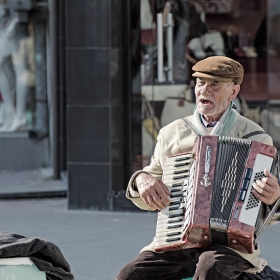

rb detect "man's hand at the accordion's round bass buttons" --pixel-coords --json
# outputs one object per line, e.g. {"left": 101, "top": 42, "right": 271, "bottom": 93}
{"left": 253, "top": 169, "right": 280, "bottom": 205}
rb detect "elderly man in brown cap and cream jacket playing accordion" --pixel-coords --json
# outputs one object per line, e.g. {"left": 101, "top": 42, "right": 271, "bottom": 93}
{"left": 116, "top": 56, "right": 280, "bottom": 280}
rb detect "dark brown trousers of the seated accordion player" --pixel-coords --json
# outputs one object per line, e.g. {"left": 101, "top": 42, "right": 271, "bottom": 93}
{"left": 116, "top": 245, "right": 280, "bottom": 280}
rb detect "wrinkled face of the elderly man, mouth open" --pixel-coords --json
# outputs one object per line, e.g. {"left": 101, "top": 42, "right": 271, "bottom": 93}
{"left": 195, "top": 78, "right": 240, "bottom": 121}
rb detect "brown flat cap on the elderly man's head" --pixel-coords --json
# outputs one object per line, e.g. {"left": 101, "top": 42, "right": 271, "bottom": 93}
{"left": 192, "top": 56, "right": 244, "bottom": 84}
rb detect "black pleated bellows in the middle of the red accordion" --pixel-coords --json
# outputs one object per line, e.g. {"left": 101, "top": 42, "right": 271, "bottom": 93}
{"left": 210, "top": 138, "right": 251, "bottom": 245}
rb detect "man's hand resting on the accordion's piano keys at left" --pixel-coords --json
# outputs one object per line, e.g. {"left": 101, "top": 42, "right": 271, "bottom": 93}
{"left": 135, "top": 173, "right": 171, "bottom": 210}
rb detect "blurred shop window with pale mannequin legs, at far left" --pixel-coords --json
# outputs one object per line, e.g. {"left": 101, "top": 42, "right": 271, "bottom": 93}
{"left": 0, "top": 0, "right": 50, "bottom": 171}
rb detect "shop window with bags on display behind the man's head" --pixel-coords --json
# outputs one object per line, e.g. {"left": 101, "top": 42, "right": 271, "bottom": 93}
{"left": 131, "top": 0, "right": 280, "bottom": 172}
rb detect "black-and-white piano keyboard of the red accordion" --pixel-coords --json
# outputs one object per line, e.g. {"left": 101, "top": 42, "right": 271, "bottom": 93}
{"left": 156, "top": 154, "right": 193, "bottom": 247}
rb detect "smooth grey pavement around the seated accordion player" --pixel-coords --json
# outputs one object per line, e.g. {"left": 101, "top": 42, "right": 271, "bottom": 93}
{"left": 0, "top": 198, "right": 280, "bottom": 280}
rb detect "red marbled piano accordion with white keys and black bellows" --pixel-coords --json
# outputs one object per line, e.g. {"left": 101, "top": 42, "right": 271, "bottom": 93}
{"left": 155, "top": 135, "right": 277, "bottom": 254}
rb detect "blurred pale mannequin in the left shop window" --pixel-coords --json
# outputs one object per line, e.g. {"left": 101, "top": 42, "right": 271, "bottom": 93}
{"left": 0, "top": 11, "right": 35, "bottom": 132}
